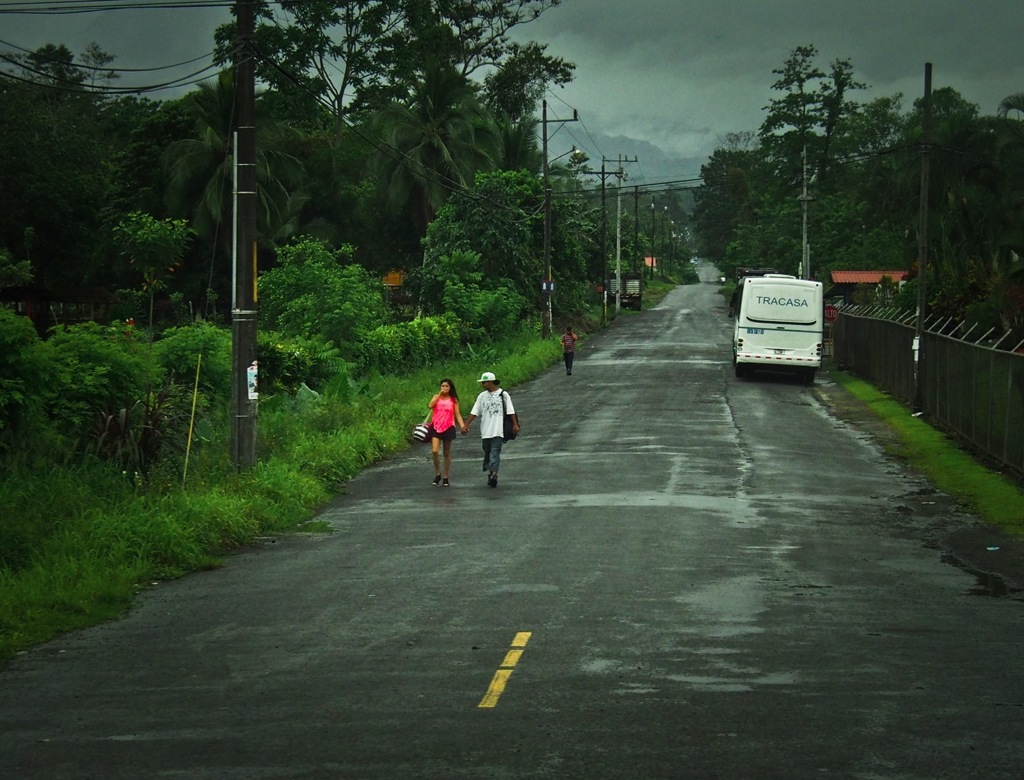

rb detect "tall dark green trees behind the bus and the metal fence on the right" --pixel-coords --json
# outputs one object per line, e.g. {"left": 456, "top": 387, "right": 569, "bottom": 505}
{"left": 694, "top": 46, "right": 1024, "bottom": 329}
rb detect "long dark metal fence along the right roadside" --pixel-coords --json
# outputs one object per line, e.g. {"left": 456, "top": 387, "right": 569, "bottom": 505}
{"left": 833, "top": 306, "right": 1024, "bottom": 477}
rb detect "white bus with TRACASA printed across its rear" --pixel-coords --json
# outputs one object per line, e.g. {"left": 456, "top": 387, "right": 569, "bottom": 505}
{"left": 732, "top": 273, "right": 824, "bottom": 384}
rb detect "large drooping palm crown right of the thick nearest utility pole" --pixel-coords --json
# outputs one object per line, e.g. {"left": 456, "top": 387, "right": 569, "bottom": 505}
{"left": 373, "top": 61, "right": 499, "bottom": 235}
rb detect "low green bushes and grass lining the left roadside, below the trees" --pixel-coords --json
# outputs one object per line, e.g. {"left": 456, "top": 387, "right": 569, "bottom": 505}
{"left": 0, "top": 269, "right": 688, "bottom": 662}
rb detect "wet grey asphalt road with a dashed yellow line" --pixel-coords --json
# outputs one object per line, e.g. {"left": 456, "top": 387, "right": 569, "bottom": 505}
{"left": 0, "top": 269, "right": 1024, "bottom": 780}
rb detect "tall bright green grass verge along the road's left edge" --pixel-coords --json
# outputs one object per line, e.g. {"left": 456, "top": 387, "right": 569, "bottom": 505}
{"left": 0, "top": 334, "right": 561, "bottom": 662}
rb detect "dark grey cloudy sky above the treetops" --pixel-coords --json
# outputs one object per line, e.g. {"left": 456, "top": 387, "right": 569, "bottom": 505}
{"left": 0, "top": 0, "right": 1024, "bottom": 179}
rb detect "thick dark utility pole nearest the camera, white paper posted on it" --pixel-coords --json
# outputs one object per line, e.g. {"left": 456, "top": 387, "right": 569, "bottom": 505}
{"left": 231, "top": 0, "right": 258, "bottom": 469}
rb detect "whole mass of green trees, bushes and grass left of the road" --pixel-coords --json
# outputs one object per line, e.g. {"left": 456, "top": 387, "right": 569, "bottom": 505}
{"left": 0, "top": 0, "right": 684, "bottom": 667}
